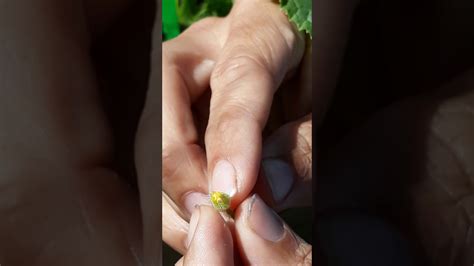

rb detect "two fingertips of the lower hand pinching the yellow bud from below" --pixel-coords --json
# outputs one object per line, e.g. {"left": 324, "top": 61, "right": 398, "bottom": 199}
{"left": 177, "top": 194, "right": 312, "bottom": 265}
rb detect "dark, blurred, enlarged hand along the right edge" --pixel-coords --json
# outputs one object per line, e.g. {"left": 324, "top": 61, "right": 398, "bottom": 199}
{"left": 317, "top": 70, "right": 474, "bottom": 266}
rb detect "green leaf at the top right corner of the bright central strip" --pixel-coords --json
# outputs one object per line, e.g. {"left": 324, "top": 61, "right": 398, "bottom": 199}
{"left": 280, "top": 0, "right": 313, "bottom": 39}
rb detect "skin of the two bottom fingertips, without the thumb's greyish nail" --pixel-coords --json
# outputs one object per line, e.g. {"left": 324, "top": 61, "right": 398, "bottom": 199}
{"left": 176, "top": 203, "right": 312, "bottom": 265}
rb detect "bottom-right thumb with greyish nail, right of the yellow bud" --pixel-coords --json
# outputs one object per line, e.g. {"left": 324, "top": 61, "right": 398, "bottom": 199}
{"left": 235, "top": 194, "right": 312, "bottom": 265}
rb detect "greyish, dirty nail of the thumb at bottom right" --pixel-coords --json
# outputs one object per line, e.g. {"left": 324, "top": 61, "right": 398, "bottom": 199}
{"left": 247, "top": 194, "right": 285, "bottom": 242}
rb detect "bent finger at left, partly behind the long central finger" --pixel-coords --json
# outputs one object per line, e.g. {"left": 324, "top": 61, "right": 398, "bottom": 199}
{"left": 158, "top": 19, "right": 223, "bottom": 214}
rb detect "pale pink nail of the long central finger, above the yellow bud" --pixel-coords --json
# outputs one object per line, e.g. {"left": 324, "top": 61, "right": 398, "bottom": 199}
{"left": 211, "top": 160, "right": 237, "bottom": 197}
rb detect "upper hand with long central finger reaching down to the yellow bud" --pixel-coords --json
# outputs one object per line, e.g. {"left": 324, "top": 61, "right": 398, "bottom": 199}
{"left": 136, "top": 1, "right": 304, "bottom": 258}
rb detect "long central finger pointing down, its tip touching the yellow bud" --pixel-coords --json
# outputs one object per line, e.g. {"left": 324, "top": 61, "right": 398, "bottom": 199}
{"left": 205, "top": 1, "right": 304, "bottom": 207}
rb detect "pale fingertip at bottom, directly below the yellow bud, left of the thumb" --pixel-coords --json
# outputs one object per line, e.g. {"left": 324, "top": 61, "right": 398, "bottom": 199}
{"left": 177, "top": 206, "right": 234, "bottom": 265}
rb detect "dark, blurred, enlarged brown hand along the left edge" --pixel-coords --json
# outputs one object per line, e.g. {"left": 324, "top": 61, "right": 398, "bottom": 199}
{"left": 0, "top": 0, "right": 142, "bottom": 265}
